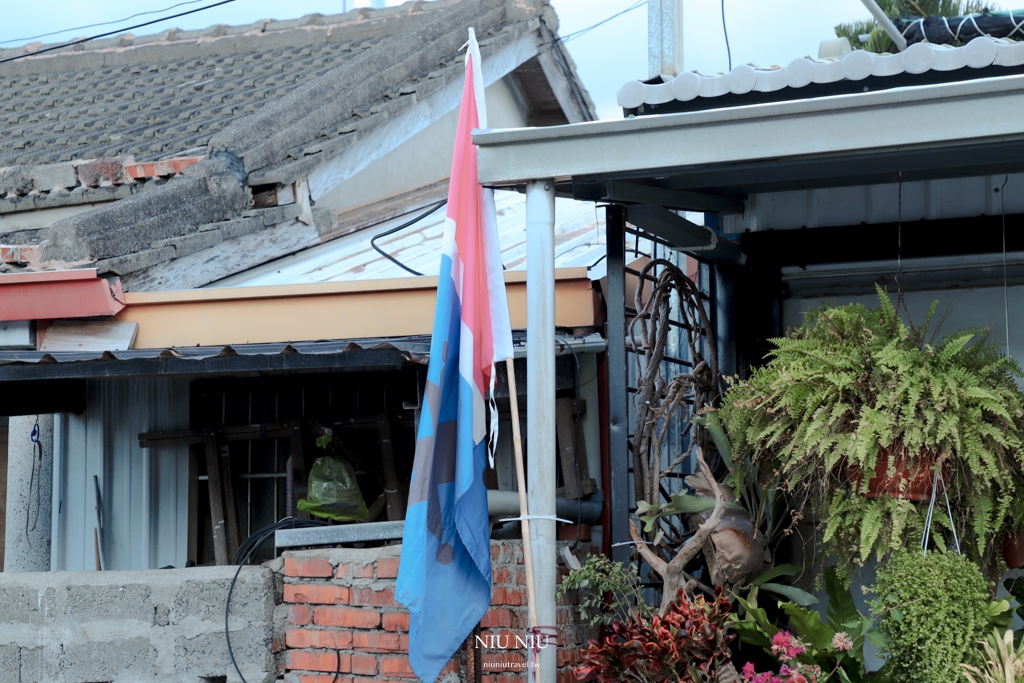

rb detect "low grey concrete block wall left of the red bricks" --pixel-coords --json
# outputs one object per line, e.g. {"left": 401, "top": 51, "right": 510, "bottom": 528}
{"left": 0, "top": 566, "right": 276, "bottom": 683}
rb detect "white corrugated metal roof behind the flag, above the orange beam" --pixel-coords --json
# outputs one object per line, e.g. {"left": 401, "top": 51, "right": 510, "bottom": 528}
{"left": 210, "top": 191, "right": 605, "bottom": 287}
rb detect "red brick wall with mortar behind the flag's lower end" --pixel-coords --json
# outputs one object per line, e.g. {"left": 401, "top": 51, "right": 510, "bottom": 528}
{"left": 280, "top": 541, "right": 593, "bottom": 683}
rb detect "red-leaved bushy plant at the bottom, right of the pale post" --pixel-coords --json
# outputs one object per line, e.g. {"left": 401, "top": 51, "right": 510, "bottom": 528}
{"left": 575, "top": 588, "right": 735, "bottom": 683}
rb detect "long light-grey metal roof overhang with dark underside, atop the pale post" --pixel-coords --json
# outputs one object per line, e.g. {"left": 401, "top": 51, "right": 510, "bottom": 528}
{"left": 473, "top": 76, "right": 1024, "bottom": 195}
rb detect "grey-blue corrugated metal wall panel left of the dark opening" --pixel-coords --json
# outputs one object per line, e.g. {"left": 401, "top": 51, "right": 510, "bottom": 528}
{"left": 53, "top": 379, "right": 188, "bottom": 571}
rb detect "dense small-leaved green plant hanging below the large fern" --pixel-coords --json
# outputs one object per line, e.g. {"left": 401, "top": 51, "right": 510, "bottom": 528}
{"left": 872, "top": 550, "right": 989, "bottom": 683}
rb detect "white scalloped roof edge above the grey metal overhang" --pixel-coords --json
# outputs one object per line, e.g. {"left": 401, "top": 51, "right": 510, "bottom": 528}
{"left": 617, "top": 38, "right": 1024, "bottom": 111}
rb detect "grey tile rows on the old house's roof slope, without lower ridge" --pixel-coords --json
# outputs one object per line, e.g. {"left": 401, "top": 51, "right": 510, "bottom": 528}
{"left": 0, "top": 0, "right": 536, "bottom": 167}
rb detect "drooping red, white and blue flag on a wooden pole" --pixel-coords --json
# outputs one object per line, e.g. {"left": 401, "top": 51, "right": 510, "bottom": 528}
{"left": 395, "top": 29, "right": 512, "bottom": 683}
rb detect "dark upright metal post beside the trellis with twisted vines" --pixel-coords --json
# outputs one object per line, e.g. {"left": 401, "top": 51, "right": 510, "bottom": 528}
{"left": 604, "top": 205, "right": 631, "bottom": 562}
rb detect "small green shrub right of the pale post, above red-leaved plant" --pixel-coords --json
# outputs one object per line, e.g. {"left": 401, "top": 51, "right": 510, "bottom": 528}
{"left": 555, "top": 555, "right": 654, "bottom": 626}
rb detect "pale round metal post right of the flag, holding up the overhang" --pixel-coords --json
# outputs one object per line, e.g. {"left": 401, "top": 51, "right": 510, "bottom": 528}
{"left": 526, "top": 180, "right": 558, "bottom": 683}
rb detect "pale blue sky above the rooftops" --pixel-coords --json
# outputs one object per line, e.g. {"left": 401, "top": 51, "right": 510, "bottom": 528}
{"left": 6, "top": 0, "right": 1024, "bottom": 119}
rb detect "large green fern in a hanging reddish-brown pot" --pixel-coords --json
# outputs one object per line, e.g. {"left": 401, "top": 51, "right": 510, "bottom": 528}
{"left": 721, "top": 288, "right": 1024, "bottom": 581}
